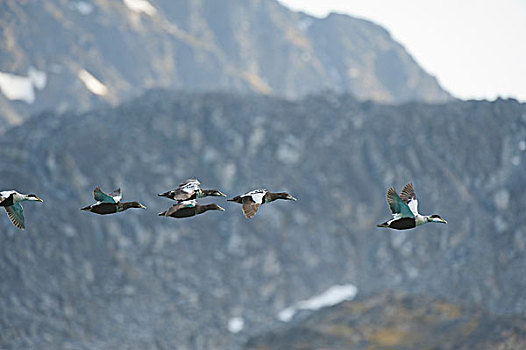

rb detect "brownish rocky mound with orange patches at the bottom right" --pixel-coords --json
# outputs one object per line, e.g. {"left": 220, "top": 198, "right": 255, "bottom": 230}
{"left": 246, "top": 293, "right": 526, "bottom": 350}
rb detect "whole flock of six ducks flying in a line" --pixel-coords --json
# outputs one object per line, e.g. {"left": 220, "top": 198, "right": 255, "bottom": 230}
{"left": 0, "top": 178, "right": 447, "bottom": 230}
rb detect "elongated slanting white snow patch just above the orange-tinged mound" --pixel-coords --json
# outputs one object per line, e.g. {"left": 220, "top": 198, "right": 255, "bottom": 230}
{"left": 278, "top": 284, "right": 358, "bottom": 322}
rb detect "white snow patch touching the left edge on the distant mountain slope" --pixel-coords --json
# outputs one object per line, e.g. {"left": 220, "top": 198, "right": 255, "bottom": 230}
{"left": 0, "top": 67, "right": 47, "bottom": 104}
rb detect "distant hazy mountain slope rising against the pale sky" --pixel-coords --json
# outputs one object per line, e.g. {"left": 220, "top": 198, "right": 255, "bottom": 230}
{"left": 0, "top": 0, "right": 450, "bottom": 132}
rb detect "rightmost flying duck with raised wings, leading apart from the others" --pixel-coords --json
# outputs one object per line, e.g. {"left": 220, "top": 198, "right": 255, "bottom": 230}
{"left": 376, "top": 183, "right": 447, "bottom": 230}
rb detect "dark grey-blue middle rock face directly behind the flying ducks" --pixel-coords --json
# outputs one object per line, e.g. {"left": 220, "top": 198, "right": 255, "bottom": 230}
{"left": 0, "top": 91, "right": 526, "bottom": 349}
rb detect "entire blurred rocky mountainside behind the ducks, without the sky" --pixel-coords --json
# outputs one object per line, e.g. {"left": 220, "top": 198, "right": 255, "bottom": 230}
{"left": 0, "top": 0, "right": 526, "bottom": 350}
